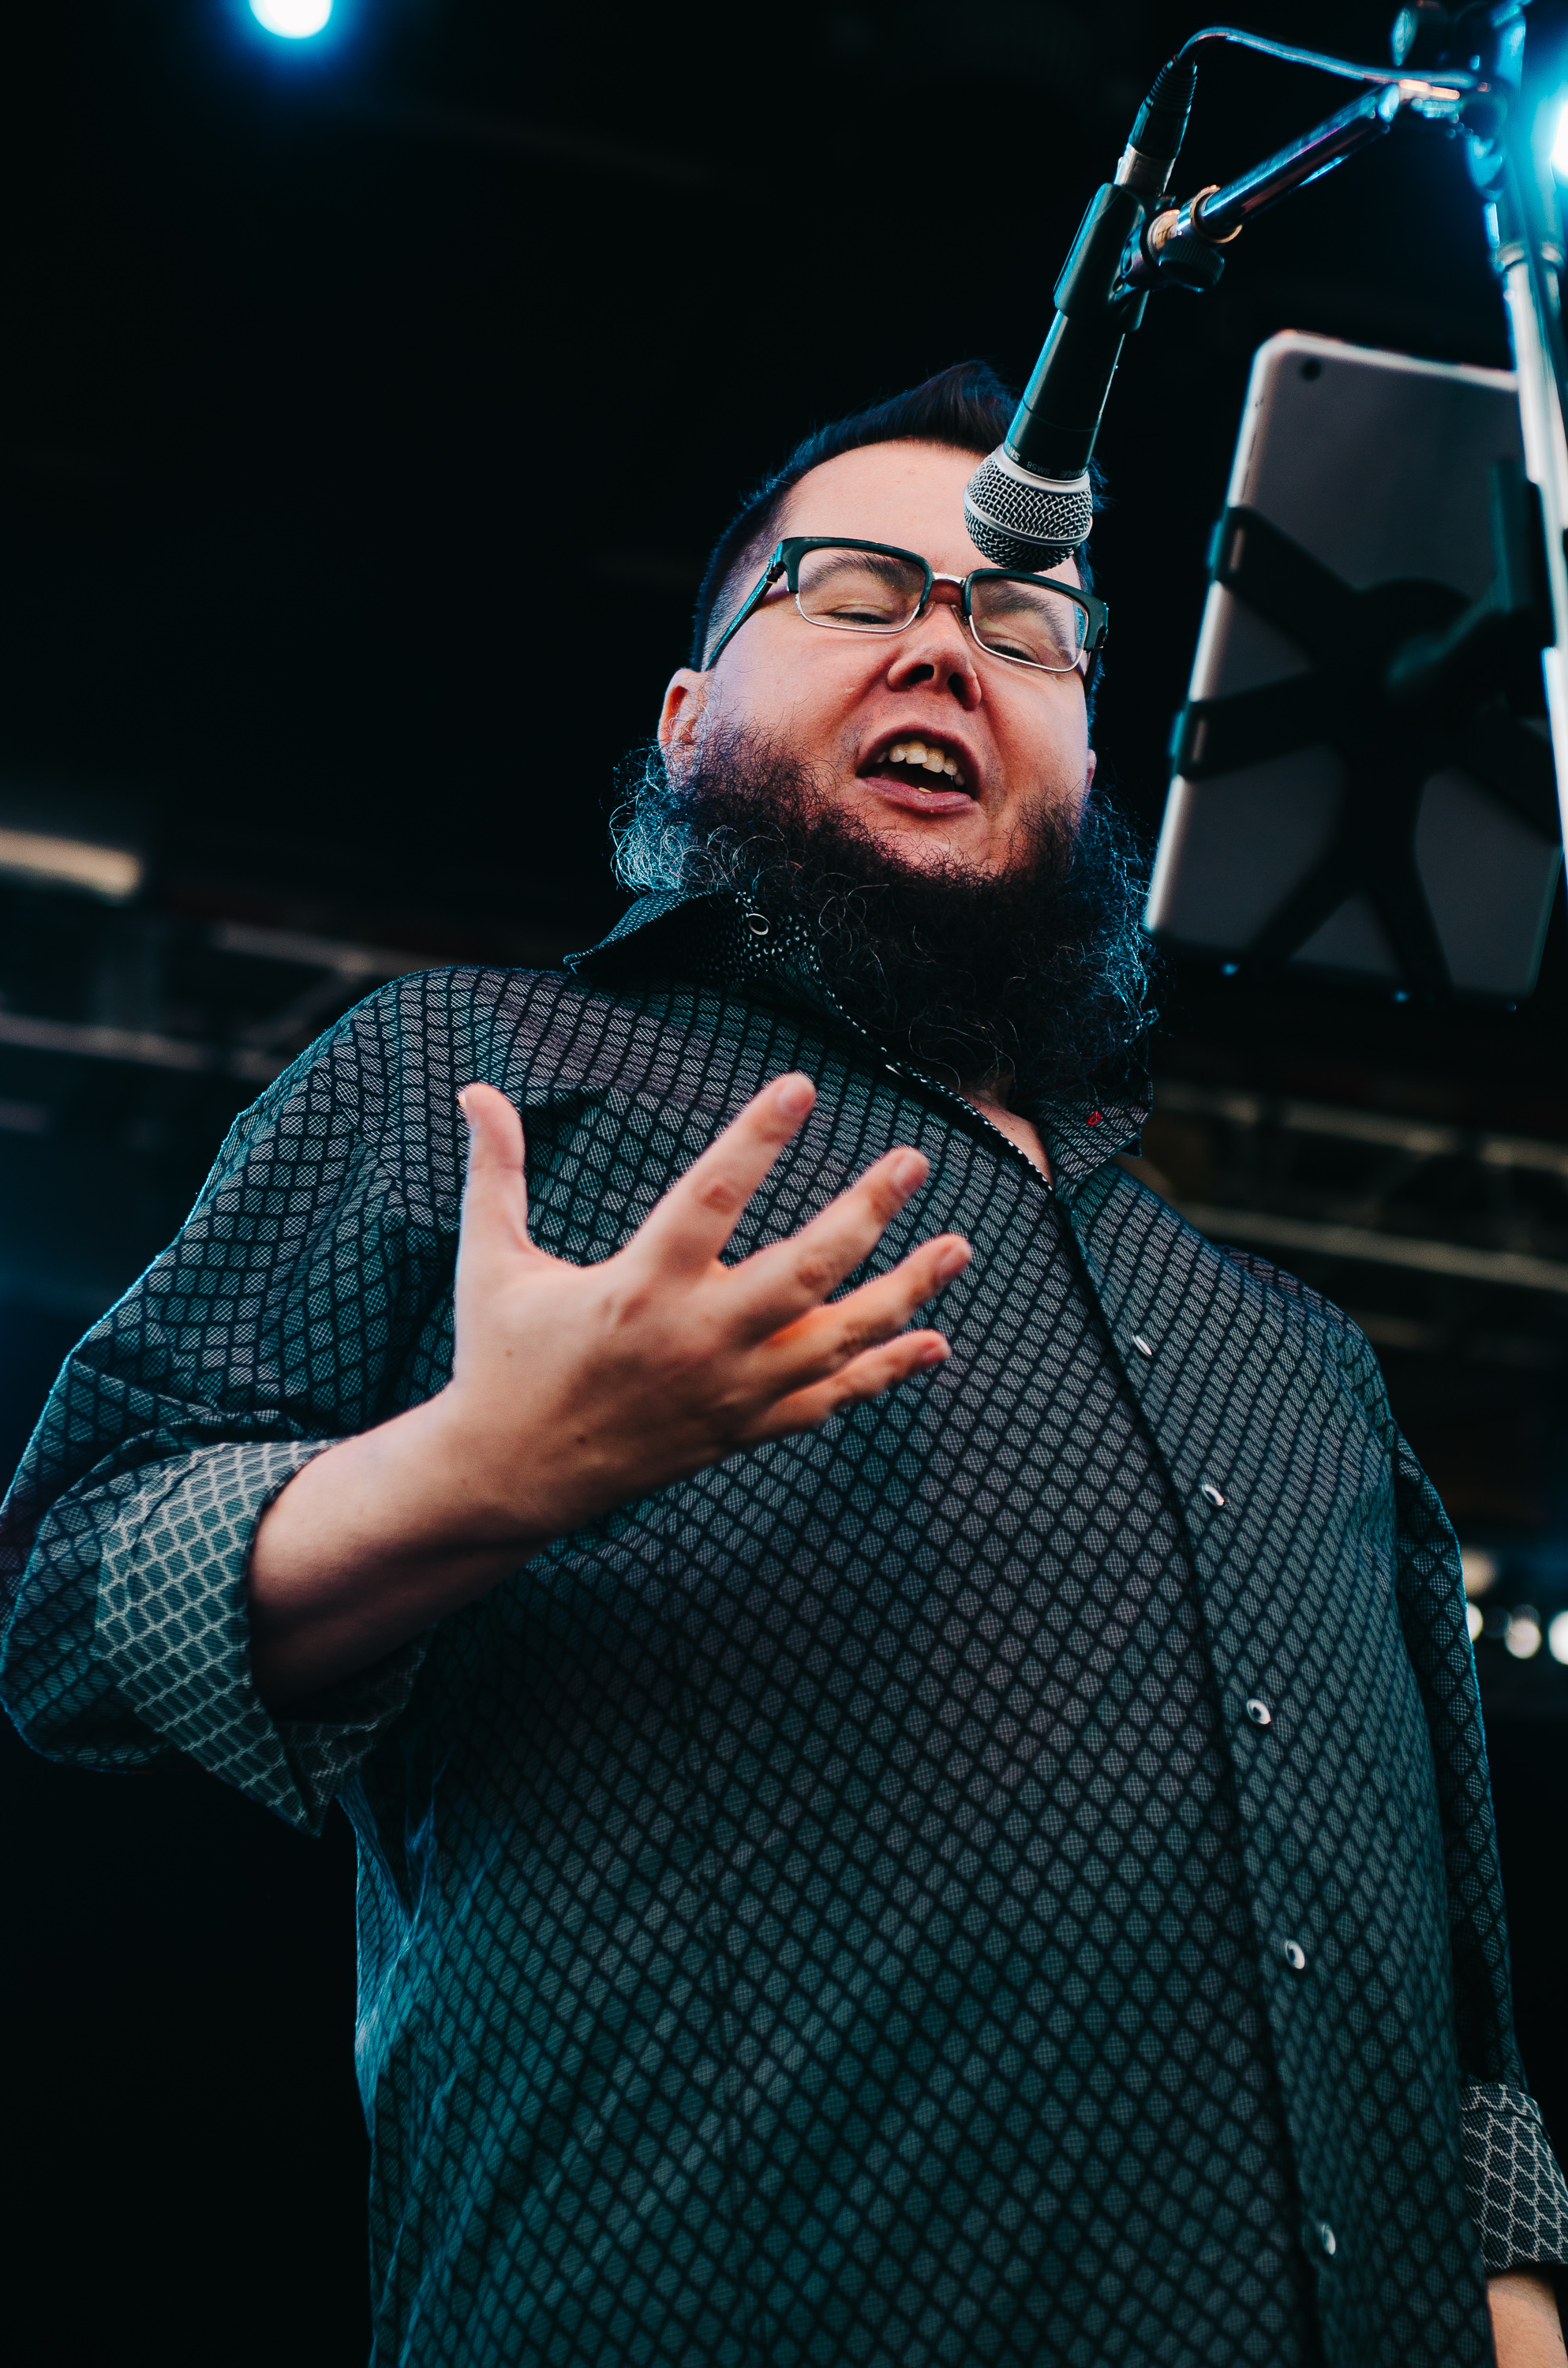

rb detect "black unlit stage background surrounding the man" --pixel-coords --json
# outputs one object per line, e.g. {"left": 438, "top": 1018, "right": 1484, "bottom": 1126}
{"left": 0, "top": 0, "right": 1568, "bottom": 2368}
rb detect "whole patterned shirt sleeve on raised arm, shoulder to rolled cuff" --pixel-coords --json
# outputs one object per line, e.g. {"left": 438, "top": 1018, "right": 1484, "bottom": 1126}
{"left": 0, "top": 999, "right": 455, "bottom": 1830}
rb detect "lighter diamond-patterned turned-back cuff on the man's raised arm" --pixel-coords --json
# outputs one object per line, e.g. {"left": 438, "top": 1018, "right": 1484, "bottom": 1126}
{"left": 95, "top": 1440, "right": 424, "bottom": 1833}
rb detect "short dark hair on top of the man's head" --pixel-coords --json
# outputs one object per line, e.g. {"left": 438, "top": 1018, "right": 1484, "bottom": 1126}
{"left": 691, "top": 362, "right": 1099, "bottom": 670}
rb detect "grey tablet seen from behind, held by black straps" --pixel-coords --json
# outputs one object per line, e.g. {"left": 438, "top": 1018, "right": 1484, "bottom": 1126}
{"left": 1147, "top": 332, "right": 1561, "bottom": 1002}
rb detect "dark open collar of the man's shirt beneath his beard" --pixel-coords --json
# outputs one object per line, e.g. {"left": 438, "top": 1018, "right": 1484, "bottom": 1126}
{"left": 566, "top": 888, "right": 1151, "bottom": 1191}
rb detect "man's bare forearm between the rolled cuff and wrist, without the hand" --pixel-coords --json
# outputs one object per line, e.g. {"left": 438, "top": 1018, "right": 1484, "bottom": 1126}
{"left": 249, "top": 1390, "right": 552, "bottom": 1703}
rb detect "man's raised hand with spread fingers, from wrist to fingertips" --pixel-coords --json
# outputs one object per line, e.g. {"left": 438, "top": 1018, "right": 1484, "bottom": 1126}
{"left": 447, "top": 1077, "right": 969, "bottom": 1542}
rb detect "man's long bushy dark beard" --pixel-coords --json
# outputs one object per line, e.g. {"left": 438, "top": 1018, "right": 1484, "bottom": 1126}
{"left": 618, "top": 729, "right": 1156, "bottom": 1103}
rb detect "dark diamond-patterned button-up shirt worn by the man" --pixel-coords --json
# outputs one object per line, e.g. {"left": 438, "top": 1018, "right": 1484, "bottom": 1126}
{"left": 0, "top": 897, "right": 1568, "bottom": 2368}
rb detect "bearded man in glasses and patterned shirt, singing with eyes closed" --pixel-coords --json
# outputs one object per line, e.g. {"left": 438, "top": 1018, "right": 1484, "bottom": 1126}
{"left": 2, "top": 369, "right": 1568, "bottom": 2368}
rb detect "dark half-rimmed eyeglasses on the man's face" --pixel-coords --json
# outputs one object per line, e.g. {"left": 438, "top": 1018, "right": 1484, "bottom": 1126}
{"left": 708, "top": 535, "right": 1109, "bottom": 680}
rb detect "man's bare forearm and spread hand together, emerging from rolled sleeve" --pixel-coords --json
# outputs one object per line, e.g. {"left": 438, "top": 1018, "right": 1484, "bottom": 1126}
{"left": 249, "top": 1075, "right": 969, "bottom": 1700}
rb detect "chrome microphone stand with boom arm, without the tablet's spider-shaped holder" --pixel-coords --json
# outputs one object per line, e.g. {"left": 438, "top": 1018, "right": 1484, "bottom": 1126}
{"left": 1144, "top": 0, "right": 1568, "bottom": 843}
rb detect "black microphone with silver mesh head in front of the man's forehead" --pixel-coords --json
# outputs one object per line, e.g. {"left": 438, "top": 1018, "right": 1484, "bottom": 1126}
{"left": 964, "top": 57, "right": 1203, "bottom": 573}
